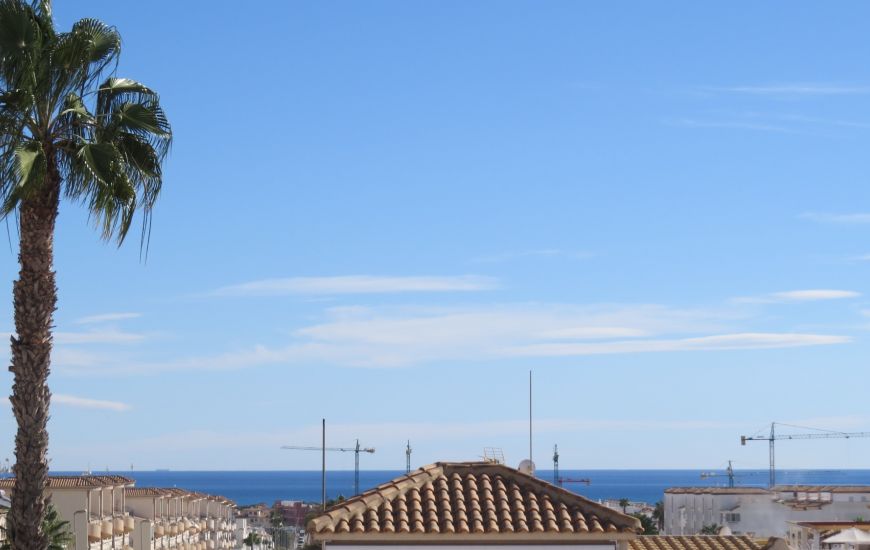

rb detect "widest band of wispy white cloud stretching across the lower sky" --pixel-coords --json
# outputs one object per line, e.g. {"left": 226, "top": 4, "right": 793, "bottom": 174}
{"left": 60, "top": 304, "right": 850, "bottom": 374}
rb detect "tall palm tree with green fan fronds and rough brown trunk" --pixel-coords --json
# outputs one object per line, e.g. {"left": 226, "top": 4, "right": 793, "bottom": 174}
{"left": 0, "top": 0, "right": 172, "bottom": 550}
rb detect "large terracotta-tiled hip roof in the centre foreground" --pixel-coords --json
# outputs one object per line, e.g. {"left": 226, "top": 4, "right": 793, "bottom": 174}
{"left": 308, "top": 462, "right": 640, "bottom": 540}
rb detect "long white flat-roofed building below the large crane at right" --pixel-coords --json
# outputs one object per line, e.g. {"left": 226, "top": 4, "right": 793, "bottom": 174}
{"left": 664, "top": 485, "right": 870, "bottom": 537}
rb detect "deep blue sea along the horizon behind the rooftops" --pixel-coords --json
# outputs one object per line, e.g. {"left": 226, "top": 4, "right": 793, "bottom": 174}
{"left": 52, "top": 470, "right": 870, "bottom": 504}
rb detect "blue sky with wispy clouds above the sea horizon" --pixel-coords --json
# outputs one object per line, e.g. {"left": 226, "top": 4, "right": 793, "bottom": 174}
{"left": 0, "top": 0, "right": 870, "bottom": 470}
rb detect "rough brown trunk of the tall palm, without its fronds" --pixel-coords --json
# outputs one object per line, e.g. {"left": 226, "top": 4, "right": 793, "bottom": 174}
{"left": 9, "top": 150, "right": 60, "bottom": 550}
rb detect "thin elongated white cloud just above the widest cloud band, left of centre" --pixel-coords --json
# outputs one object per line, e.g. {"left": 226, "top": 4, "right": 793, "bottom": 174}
{"left": 212, "top": 275, "right": 498, "bottom": 296}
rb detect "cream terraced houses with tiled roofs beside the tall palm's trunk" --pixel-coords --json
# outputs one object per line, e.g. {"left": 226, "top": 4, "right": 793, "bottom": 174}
{"left": 0, "top": 475, "right": 246, "bottom": 550}
